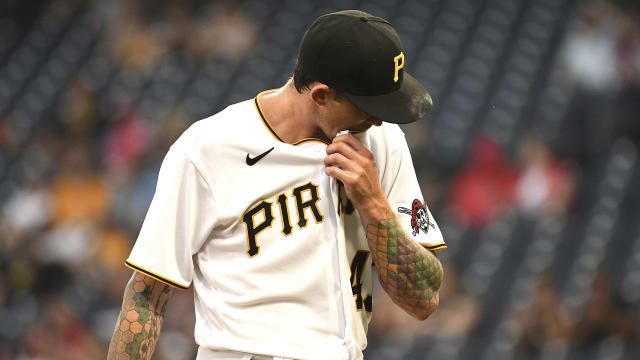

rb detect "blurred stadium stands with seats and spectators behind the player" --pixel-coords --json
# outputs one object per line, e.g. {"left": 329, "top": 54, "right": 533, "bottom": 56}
{"left": 0, "top": 0, "right": 640, "bottom": 360}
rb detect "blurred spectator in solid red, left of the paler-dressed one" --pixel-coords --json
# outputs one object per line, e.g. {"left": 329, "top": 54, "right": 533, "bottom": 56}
{"left": 450, "top": 137, "right": 517, "bottom": 227}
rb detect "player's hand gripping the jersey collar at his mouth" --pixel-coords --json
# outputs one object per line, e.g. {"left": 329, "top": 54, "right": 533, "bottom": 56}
{"left": 324, "top": 134, "right": 388, "bottom": 216}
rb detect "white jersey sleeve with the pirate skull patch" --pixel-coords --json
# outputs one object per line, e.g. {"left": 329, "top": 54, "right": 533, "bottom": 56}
{"left": 382, "top": 128, "right": 447, "bottom": 251}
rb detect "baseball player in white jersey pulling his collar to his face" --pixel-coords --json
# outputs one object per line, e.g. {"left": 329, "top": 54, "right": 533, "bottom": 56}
{"left": 108, "top": 10, "right": 446, "bottom": 360}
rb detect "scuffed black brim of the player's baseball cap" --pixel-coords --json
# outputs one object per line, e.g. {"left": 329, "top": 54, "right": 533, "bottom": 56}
{"left": 343, "top": 72, "right": 432, "bottom": 124}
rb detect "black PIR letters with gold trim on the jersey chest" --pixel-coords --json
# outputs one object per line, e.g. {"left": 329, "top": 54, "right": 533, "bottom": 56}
{"left": 242, "top": 183, "right": 324, "bottom": 257}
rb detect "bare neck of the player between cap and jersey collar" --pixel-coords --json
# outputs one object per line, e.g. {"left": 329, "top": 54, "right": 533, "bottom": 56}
{"left": 260, "top": 79, "right": 329, "bottom": 144}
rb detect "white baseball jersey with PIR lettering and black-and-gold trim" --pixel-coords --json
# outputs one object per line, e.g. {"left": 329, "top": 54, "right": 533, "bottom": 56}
{"left": 126, "top": 90, "right": 446, "bottom": 360}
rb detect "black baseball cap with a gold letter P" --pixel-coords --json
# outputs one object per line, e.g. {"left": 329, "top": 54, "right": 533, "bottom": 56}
{"left": 298, "top": 10, "right": 432, "bottom": 124}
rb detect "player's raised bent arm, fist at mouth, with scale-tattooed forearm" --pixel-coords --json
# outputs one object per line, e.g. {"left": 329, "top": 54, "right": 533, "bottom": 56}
{"left": 325, "top": 134, "right": 443, "bottom": 320}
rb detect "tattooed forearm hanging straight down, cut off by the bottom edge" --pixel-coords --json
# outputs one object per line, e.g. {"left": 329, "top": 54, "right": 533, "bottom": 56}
{"left": 107, "top": 272, "right": 172, "bottom": 360}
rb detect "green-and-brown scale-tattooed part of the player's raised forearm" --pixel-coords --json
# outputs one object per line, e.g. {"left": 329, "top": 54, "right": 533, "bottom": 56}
{"left": 366, "top": 213, "right": 442, "bottom": 319}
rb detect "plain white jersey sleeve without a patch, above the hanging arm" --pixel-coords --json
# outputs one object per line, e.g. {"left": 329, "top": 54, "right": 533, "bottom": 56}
{"left": 125, "top": 147, "right": 217, "bottom": 289}
